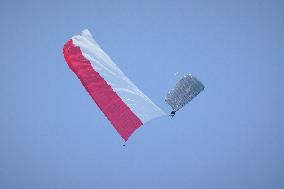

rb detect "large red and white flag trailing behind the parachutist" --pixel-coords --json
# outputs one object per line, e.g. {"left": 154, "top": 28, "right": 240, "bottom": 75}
{"left": 63, "top": 30, "right": 165, "bottom": 141}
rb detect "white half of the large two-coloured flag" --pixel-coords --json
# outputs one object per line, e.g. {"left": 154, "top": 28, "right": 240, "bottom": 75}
{"left": 72, "top": 29, "right": 166, "bottom": 123}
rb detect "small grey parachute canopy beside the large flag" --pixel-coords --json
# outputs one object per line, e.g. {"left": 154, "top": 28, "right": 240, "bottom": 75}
{"left": 165, "top": 74, "right": 204, "bottom": 112}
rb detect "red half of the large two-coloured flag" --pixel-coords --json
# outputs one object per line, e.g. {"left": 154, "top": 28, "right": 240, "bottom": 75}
{"left": 63, "top": 40, "right": 142, "bottom": 141}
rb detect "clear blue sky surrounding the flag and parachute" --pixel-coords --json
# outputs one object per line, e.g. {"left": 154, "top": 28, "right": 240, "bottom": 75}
{"left": 0, "top": 0, "right": 284, "bottom": 189}
